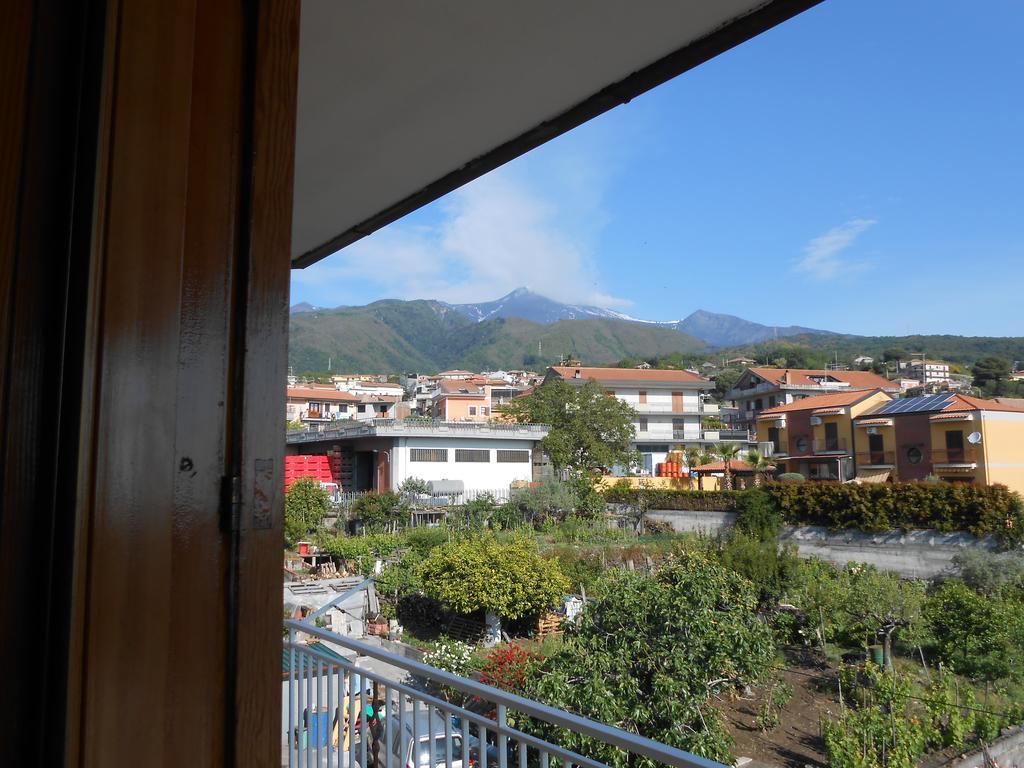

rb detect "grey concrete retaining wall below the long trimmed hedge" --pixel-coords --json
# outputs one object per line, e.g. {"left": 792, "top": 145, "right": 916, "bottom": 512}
{"left": 648, "top": 510, "right": 996, "bottom": 579}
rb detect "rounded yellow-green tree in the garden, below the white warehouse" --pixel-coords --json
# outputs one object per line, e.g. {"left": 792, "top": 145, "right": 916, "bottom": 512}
{"left": 418, "top": 535, "right": 568, "bottom": 618}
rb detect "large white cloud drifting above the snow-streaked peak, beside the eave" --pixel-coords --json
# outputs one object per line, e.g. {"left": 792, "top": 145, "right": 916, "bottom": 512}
{"left": 292, "top": 169, "right": 629, "bottom": 307}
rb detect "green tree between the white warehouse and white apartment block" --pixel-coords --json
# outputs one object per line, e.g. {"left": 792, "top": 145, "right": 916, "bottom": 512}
{"left": 503, "top": 379, "right": 637, "bottom": 475}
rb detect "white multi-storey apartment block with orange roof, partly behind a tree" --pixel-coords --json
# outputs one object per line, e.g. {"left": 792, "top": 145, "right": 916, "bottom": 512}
{"left": 545, "top": 366, "right": 733, "bottom": 474}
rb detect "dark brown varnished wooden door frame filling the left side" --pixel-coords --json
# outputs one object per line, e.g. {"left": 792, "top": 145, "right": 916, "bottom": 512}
{"left": 0, "top": 0, "right": 299, "bottom": 765}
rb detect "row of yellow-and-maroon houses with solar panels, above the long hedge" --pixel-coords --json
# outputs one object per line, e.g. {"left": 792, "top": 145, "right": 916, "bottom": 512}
{"left": 758, "top": 389, "right": 1024, "bottom": 492}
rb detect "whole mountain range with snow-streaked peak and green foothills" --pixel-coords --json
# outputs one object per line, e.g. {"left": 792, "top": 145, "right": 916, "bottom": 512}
{"left": 289, "top": 288, "right": 830, "bottom": 372}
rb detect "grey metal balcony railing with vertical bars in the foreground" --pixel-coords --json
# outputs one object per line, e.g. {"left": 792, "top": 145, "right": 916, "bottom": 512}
{"left": 283, "top": 621, "right": 720, "bottom": 768}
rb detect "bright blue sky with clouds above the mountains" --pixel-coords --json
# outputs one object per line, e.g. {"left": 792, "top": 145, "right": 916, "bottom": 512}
{"left": 292, "top": 0, "right": 1024, "bottom": 336}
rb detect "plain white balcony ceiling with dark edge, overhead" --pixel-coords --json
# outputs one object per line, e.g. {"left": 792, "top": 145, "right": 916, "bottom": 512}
{"left": 292, "top": 0, "right": 818, "bottom": 266}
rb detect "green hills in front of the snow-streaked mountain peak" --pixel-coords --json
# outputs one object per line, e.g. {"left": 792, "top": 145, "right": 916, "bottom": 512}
{"left": 288, "top": 301, "right": 705, "bottom": 373}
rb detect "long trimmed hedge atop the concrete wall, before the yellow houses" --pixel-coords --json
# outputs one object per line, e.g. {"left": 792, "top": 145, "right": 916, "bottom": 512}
{"left": 604, "top": 482, "right": 1024, "bottom": 544}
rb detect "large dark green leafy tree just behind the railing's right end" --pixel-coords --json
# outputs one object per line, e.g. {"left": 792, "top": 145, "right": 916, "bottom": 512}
{"left": 527, "top": 553, "right": 774, "bottom": 766}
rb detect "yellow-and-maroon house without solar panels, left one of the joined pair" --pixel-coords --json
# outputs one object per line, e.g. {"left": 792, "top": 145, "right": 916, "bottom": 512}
{"left": 757, "top": 389, "right": 892, "bottom": 481}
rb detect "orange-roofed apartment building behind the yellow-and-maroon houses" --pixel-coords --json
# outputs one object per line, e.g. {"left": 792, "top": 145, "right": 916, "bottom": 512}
{"left": 725, "top": 368, "right": 900, "bottom": 429}
